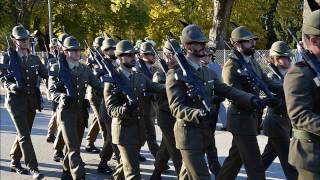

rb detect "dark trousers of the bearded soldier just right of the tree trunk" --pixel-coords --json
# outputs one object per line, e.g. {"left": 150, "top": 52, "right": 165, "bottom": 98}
{"left": 217, "top": 134, "right": 265, "bottom": 180}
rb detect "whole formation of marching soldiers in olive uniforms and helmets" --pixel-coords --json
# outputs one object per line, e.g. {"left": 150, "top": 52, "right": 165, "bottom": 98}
{"left": 0, "top": 10, "right": 320, "bottom": 180}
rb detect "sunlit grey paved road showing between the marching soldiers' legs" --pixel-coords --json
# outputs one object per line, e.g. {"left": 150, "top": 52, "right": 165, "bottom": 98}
{"left": 0, "top": 97, "right": 285, "bottom": 180}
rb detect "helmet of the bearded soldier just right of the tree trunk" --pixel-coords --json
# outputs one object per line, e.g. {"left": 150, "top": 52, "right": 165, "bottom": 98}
{"left": 230, "top": 26, "right": 257, "bottom": 43}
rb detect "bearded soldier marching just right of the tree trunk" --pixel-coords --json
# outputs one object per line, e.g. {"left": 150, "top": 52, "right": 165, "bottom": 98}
{"left": 217, "top": 26, "right": 283, "bottom": 180}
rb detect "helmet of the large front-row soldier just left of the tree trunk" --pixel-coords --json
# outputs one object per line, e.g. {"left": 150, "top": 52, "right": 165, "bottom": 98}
{"left": 180, "top": 24, "right": 208, "bottom": 43}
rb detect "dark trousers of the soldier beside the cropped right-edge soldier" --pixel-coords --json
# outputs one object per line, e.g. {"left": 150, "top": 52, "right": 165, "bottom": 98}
{"left": 262, "top": 137, "right": 298, "bottom": 180}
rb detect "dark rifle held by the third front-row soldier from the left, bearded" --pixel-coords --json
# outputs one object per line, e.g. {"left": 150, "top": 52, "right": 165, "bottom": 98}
{"left": 97, "top": 47, "right": 138, "bottom": 106}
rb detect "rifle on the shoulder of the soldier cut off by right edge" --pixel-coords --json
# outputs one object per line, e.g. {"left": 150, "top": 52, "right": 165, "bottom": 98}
{"left": 287, "top": 28, "right": 320, "bottom": 87}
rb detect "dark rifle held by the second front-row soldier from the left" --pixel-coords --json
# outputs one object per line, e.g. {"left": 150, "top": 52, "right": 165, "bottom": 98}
{"left": 49, "top": 40, "right": 76, "bottom": 97}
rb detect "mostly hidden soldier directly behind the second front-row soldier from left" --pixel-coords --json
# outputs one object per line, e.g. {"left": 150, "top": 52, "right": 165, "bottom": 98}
{"left": 49, "top": 33, "right": 69, "bottom": 162}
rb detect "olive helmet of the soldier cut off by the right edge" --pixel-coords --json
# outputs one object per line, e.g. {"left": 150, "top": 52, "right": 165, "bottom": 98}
{"left": 302, "top": 9, "right": 320, "bottom": 36}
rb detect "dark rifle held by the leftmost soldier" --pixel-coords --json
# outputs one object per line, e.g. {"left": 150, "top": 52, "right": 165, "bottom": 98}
{"left": 0, "top": 37, "right": 24, "bottom": 89}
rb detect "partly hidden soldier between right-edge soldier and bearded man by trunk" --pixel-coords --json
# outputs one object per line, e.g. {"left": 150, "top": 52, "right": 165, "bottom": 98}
{"left": 262, "top": 41, "right": 298, "bottom": 180}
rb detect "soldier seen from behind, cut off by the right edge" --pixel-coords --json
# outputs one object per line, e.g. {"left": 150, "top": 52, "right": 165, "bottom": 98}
{"left": 284, "top": 10, "right": 320, "bottom": 180}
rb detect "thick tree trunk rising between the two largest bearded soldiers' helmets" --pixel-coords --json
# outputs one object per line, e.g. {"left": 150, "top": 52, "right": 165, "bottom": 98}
{"left": 209, "top": 0, "right": 234, "bottom": 49}
